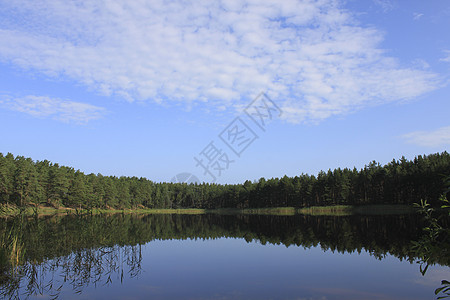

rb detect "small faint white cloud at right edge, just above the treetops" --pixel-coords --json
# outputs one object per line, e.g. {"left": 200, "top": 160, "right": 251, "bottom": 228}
{"left": 402, "top": 126, "right": 450, "bottom": 147}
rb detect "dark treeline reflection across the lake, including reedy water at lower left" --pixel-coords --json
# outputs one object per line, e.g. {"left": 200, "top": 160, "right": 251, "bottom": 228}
{"left": 0, "top": 214, "right": 450, "bottom": 298}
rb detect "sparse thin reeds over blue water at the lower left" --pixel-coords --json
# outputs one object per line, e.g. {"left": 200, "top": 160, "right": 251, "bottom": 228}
{"left": 1, "top": 245, "right": 142, "bottom": 299}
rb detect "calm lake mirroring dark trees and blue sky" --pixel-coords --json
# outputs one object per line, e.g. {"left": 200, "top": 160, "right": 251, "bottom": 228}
{"left": 0, "top": 214, "right": 450, "bottom": 299}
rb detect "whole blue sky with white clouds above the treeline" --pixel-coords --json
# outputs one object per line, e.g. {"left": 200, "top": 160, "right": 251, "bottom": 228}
{"left": 0, "top": 0, "right": 450, "bottom": 183}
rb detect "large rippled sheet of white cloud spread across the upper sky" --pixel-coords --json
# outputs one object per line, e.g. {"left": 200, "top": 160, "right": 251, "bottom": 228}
{"left": 0, "top": 0, "right": 438, "bottom": 122}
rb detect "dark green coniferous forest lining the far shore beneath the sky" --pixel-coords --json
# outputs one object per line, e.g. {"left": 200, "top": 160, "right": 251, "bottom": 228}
{"left": 0, "top": 152, "right": 450, "bottom": 209}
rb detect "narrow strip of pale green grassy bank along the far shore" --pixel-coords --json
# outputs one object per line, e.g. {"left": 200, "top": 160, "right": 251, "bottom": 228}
{"left": 0, "top": 205, "right": 414, "bottom": 217}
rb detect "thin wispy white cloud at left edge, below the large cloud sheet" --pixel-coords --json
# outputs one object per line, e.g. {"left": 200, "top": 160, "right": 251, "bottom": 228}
{"left": 0, "top": 95, "right": 105, "bottom": 124}
